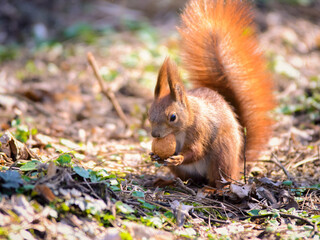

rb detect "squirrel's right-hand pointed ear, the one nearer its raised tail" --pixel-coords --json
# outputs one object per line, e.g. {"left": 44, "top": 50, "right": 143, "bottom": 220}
{"left": 166, "top": 59, "right": 187, "bottom": 106}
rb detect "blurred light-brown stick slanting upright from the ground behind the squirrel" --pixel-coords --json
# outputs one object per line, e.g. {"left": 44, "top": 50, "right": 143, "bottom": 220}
{"left": 87, "top": 52, "right": 130, "bottom": 128}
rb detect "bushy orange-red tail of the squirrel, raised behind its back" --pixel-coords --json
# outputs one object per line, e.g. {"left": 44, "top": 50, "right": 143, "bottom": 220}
{"left": 179, "top": 0, "right": 274, "bottom": 161}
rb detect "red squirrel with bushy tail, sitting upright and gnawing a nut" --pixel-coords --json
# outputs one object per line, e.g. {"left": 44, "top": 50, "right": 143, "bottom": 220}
{"left": 149, "top": 0, "right": 274, "bottom": 187}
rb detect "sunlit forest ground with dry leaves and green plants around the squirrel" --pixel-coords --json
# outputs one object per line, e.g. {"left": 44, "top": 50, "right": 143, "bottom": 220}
{"left": 0, "top": 0, "right": 320, "bottom": 239}
